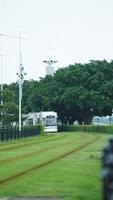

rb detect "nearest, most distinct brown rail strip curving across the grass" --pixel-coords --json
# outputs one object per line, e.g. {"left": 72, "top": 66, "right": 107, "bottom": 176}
{"left": 0, "top": 136, "right": 100, "bottom": 185}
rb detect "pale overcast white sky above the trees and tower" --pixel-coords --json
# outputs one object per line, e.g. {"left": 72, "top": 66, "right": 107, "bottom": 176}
{"left": 0, "top": 0, "right": 113, "bottom": 83}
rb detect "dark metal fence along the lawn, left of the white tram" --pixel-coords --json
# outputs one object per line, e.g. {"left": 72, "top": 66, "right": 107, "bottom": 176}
{"left": 0, "top": 127, "right": 40, "bottom": 142}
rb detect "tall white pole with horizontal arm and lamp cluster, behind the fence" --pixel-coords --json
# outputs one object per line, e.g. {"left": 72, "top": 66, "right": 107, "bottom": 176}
{"left": 0, "top": 32, "right": 26, "bottom": 132}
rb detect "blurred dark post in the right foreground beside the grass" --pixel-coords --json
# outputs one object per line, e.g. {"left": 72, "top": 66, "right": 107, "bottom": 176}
{"left": 102, "top": 139, "right": 113, "bottom": 200}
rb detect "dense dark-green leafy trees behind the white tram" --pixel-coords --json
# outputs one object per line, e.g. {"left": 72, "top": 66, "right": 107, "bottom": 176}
{"left": 0, "top": 60, "right": 113, "bottom": 124}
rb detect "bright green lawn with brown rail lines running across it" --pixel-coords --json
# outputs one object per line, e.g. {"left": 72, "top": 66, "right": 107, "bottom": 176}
{"left": 0, "top": 132, "right": 111, "bottom": 200}
